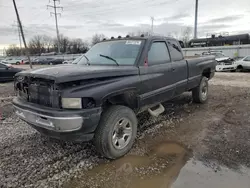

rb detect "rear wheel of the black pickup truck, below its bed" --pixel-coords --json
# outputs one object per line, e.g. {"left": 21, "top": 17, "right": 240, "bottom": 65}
{"left": 192, "top": 76, "right": 208, "bottom": 103}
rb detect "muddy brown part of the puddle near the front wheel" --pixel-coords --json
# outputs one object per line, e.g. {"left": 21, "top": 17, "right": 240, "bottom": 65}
{"left": 65, "top": 143, "right": 190, "bottom": 188}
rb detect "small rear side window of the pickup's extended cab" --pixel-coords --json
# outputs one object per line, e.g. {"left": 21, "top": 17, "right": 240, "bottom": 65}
{"left": 168, "top": 40, "right": 184, "bottom": 61}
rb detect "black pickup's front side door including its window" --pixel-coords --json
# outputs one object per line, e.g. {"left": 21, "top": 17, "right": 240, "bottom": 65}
{"left": 139, "top": 40, "right": 175, "bottom": 106}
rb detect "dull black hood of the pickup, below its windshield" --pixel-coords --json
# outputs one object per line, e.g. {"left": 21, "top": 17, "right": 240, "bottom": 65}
{"left": 16, "top": 65, "right": 139, "bottom": 83}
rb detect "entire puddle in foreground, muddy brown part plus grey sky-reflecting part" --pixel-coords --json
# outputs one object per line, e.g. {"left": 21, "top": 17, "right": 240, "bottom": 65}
{"left": 65, "top": 143, "right": 250, "bottom": 188}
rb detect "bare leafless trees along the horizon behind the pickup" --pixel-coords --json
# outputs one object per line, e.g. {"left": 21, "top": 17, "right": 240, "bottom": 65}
{"left": 6, "top": 27, "right": 192, "bottom": 56}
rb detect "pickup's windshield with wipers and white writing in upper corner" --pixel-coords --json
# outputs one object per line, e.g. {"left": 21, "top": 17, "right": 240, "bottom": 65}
{"left": 72, "top": 40, "right": 143, "bottom": 66}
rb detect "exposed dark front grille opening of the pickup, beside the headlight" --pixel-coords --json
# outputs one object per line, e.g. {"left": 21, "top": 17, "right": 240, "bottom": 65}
{"left": 15, "top": 78, "right": 59, "bottom": 108}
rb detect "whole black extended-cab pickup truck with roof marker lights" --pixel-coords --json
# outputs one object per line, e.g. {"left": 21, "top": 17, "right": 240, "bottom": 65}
{"left": 13, "top": 36, "right": 216, "bottom": 159}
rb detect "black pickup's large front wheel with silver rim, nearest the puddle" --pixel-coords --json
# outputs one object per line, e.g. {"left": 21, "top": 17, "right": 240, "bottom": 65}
{"left": 94, "top": 106, "right": 137, "bottom": 159}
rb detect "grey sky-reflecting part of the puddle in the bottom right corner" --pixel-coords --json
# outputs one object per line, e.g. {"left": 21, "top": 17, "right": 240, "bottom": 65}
{"left": 171, "top": 159, "right": 250, "bottom": 188}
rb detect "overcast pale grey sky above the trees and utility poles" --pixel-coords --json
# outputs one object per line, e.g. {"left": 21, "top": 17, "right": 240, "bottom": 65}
{"left": 0, "top": 0, "right": 250, "bottom": 48}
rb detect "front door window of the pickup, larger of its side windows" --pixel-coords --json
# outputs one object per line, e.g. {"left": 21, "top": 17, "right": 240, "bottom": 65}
{"left": 148, "top": 42, "right": 170, "bottom": 65}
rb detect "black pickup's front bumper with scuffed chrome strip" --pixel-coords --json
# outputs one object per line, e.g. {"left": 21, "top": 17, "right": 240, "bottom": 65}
{"left": 13, "top": 98, "right": 102, "bottom": 142}
